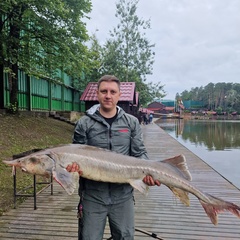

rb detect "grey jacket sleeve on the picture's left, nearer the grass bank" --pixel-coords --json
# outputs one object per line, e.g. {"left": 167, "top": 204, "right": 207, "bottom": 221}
{"left": 72, "top": 117, "right": 87, "bottom": 144}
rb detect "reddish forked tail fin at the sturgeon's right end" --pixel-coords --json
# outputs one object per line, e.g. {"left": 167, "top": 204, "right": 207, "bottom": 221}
{"left": 199, "top": 194, "right": 240, "bottom": 225}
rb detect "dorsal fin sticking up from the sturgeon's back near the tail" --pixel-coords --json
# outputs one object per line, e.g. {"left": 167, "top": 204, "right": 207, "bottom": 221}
{"left": 161, "top": 154, "right": 192, "bottom": 181}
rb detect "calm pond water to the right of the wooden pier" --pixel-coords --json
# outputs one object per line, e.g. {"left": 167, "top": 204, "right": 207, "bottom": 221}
{"left": 158, "top": 119, "right": 240, "bottom": 188}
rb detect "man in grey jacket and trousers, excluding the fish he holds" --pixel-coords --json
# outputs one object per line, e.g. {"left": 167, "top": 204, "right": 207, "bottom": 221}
{"left": 67, "top": 75, "right": 160, "bottom": 240}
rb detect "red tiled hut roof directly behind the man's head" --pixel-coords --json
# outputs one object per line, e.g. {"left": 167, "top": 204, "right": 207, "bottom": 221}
{"left": 80, "top": 82, "right": 136, "bottom": 102}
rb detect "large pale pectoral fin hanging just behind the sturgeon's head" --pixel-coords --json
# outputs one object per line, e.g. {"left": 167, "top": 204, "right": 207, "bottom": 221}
{"left": 53, "top": 164, "right": 79, "bottom": 195}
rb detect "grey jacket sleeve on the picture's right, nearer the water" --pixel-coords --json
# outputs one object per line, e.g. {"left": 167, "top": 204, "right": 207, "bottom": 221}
{"left": 130, "top": 119, "right": 148, "bottom": 159}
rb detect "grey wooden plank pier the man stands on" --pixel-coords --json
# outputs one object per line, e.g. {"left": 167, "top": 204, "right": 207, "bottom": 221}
{"left": 0, "top": 124, "right": 240, "bottom": 240}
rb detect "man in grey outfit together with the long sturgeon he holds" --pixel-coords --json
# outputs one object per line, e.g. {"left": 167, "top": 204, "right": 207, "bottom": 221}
{"left": 3, "top": 75, "right": 240, "bottom": 240}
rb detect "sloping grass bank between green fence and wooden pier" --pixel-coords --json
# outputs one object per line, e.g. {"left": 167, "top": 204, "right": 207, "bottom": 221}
{"left": 0, "top": 114, "right": 74, "bottom": 216}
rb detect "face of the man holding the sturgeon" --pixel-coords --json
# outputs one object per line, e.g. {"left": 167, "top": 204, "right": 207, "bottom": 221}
{"left": 97, "top": 81, "right": 121, "bottom": 111}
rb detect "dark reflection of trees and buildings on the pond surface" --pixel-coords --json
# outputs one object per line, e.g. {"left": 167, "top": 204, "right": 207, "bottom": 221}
{"left": 159, "top": 119, "right": 240, "bottom": 151}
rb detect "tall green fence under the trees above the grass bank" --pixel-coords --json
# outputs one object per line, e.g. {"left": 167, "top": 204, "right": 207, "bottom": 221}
{"left": 4, "top": 70, "right": 85, "bottom": 112}
